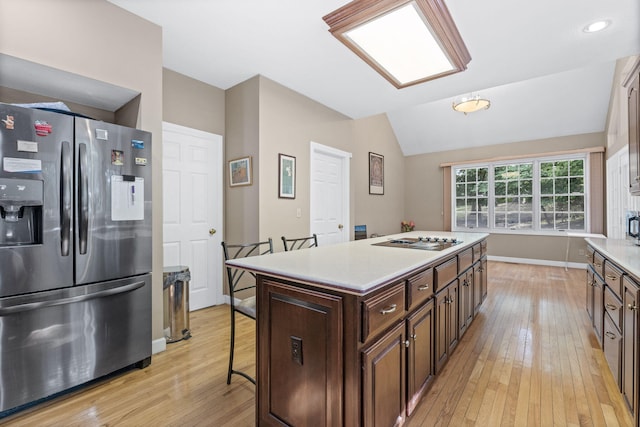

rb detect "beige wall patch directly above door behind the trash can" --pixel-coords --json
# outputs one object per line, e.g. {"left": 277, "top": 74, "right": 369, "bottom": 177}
{"left": 162, "top": 68, "right": 225, "bottom": 136}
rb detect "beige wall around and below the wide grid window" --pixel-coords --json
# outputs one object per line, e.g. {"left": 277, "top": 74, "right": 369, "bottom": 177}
{"left": 405, "top": 133, "right": 606, "bottom": 263}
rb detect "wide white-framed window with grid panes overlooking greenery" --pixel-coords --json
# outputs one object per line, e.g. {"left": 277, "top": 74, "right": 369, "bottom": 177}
{"left": 451, "top": 154, "right": 588, "bottom": 233}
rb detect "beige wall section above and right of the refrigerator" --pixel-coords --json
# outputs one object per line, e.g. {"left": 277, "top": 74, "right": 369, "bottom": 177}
{"left": 0, "top": 0, "right": 163, "bottom": 339}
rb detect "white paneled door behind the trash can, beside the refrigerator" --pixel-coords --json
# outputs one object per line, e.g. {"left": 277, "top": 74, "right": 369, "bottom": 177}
{"left": 162, "top": 123, "right": 224, "bottom": 310}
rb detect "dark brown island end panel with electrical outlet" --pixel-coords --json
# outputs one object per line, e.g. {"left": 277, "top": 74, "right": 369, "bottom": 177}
{"left": 256, "top": 280, "right": 343, "bottom": 426}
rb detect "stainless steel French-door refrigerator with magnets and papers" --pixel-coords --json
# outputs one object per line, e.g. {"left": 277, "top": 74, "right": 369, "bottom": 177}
{"left": 0, "top": 103, "right": 151, "bottom": 416}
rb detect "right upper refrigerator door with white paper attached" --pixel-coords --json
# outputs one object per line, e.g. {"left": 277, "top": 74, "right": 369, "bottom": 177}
{"left": 75, "top": 118, "right": 151, "bottom": 284}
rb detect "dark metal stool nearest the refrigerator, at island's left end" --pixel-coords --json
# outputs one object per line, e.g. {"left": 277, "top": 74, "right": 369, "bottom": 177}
{"left": 222, "top": 238, "right": 273, "bottom": 384}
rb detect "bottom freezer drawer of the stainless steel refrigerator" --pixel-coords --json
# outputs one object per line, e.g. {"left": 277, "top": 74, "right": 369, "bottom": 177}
{"left": 0, "top": 275, "right": 151, "bottom": 414}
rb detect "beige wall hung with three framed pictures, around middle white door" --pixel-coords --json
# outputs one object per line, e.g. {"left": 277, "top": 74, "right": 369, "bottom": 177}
{"left": 225, "top": 76, "right": 404, "bottom": 251}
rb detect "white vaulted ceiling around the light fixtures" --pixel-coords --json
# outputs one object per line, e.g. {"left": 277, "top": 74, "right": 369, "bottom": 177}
{"left": 109, "top": 0, "right": 640, "bottom": 155}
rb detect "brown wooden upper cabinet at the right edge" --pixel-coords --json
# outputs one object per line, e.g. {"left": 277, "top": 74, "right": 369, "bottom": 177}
{"left": 625, "top": 60, "right": 640, "bottom": 196}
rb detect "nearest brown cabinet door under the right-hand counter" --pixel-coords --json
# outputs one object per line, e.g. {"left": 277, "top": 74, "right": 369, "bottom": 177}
{"left": 622, "top": 276, "right": 640, "bottom": 425}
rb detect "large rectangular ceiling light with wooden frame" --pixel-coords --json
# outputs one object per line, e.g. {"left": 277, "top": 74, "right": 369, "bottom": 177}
{"left": 322, "top": 0, "right": 471, "bottom": 89}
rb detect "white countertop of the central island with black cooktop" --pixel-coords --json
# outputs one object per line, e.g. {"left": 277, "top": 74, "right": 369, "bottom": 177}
{"left": 222, "top": 231, "right": 488, "bottom": 294}
